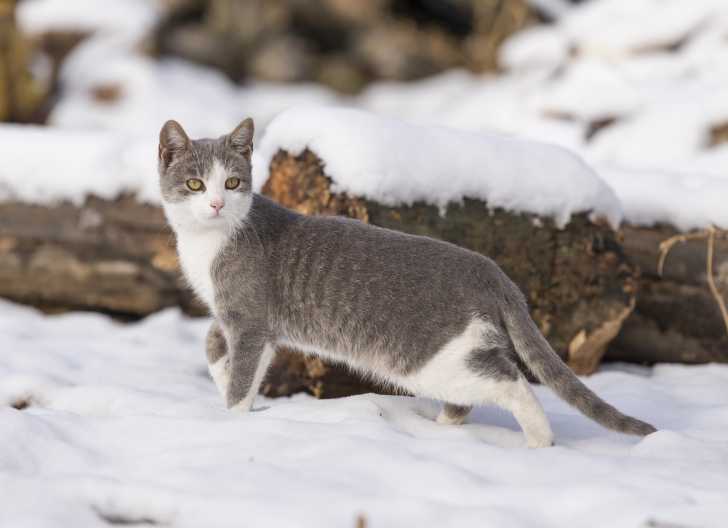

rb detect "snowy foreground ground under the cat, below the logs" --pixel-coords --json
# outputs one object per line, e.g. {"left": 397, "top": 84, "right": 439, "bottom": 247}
{"left": 0, "top": 302, "right": 728, "bottom": 528}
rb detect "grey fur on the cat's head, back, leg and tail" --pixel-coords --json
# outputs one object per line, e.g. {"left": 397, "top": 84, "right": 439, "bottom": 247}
{"left": 159, "top": 122, "right": 655, "bottom": 442}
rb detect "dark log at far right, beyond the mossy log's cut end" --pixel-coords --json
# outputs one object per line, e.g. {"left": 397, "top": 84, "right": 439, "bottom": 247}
{"left": 606, "top": 225, "right": 728, "bottom": 364}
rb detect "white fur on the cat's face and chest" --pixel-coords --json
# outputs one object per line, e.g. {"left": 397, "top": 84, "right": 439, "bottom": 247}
{"left": 164, "top": 160, "right": 252, "bottom": 312}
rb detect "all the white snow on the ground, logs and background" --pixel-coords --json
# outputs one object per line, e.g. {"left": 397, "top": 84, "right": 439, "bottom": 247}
{"left": 0, "top": 0, "right": 728, "bottom": 528}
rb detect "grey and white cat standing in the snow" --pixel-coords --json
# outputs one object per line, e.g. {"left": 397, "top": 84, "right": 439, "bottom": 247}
{"left": 159, "top": 119, "right": 655, "bottom": 447}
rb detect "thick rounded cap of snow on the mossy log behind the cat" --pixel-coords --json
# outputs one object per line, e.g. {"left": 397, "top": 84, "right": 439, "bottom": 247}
{"left": 257, "top": 107, "right": 621, "bottom": 226}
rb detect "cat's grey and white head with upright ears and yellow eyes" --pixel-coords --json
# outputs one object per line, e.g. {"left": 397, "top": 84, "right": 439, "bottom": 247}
{"left": 159, "top": 118, "right": 253, "bottom": 230}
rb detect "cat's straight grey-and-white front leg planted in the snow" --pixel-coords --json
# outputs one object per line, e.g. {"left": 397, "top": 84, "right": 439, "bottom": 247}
{"left": 226, "top": 322, "right": 274, "bottom": 412}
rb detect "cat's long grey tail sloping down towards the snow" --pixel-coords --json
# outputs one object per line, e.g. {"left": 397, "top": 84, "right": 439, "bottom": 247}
{"left": 502, "top": 285, "right": 657, "bottom": 436}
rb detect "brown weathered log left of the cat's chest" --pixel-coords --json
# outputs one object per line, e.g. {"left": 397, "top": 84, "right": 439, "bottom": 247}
{"left": 0, "top": 196, "right": 204, "bottom": 318}
